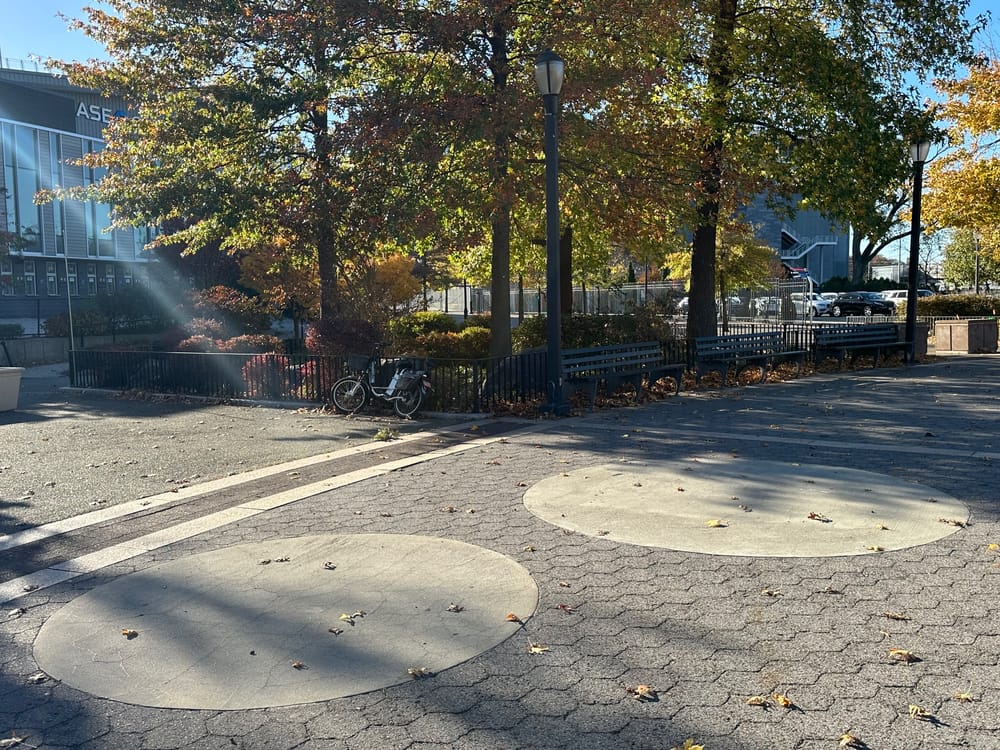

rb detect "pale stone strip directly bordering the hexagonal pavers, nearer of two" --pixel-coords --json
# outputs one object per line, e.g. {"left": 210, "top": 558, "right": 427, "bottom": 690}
{"left": 0, "top": 423, "right": 548, "bottom": 604}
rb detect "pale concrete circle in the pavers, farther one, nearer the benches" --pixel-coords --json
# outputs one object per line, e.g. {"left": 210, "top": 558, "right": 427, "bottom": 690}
{"left": 524, "top": 456, "right": 968, "bottom": 557}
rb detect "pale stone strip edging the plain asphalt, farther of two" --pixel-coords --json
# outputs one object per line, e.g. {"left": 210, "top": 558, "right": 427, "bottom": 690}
{"left": 0, "top": 419, "right": 529, "bottom": 552}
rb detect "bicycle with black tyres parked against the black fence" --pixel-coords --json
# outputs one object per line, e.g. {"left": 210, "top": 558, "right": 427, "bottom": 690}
{"left": 330, "top": 350, "right": 431, "bottom": 417}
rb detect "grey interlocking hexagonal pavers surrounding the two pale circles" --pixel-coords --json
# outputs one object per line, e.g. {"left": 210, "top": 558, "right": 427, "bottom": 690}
{"left": 0, "top": 358, "right": 1000, "bottom": 750}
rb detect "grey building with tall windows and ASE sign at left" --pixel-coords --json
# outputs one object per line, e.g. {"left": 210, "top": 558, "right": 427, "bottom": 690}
{"left": 0, "top": 61, "right": 149, "bottom": 333}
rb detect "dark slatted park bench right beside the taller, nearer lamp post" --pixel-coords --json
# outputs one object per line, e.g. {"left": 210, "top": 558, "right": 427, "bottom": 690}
{"left": 562, "top": 341, "right": 687, "bottom": 411}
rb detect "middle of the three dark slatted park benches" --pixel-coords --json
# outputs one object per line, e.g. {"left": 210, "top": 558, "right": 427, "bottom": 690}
{"left": 694, "top": 331, "right": 808, "bottom": 387}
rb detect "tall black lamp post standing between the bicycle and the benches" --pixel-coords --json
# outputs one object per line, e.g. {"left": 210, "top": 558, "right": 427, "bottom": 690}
{"left": 535, "top": 50, "right": 569, "bottom": 414}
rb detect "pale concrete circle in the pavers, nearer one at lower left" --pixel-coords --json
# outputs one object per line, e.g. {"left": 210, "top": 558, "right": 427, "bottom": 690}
{"left": 35, "top": 534, "right": 538, "bottom": 709}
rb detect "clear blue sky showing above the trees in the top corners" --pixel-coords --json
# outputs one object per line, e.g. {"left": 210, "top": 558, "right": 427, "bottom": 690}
{"left": 0, "top": 0, "right": 1000, "bottom": 66}
